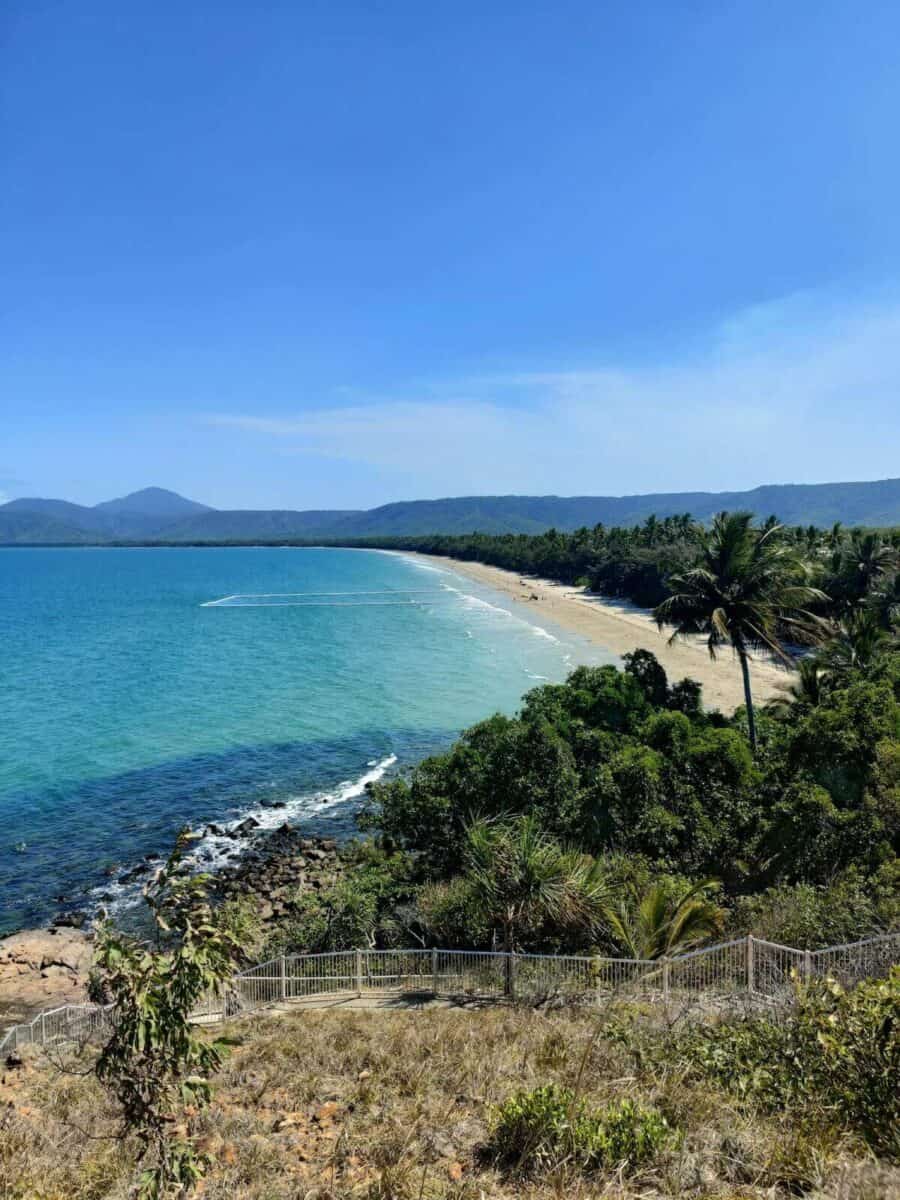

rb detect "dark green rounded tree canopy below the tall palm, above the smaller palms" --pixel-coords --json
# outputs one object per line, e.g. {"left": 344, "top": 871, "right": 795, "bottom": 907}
{"left": 366, "top": 654, "right": 900, "bottom": 912}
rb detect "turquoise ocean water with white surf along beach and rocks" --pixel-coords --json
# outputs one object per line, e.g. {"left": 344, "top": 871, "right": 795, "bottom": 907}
{"left": 0, "top": 548, "right": 613, "bottom": 932}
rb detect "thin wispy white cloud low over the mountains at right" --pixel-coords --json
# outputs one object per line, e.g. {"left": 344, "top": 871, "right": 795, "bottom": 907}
{"left": 212, "top": 295, "right": 900, "bottom": 496}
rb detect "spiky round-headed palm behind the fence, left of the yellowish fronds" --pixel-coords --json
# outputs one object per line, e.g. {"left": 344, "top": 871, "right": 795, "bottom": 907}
{"left": 466, "top": 815, "right": 607, "bottom": 969}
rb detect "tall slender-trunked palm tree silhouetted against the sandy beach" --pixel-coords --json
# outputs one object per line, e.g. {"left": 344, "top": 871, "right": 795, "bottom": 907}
{"left": 654, "top": 512, "right": 827, "bottom": 754}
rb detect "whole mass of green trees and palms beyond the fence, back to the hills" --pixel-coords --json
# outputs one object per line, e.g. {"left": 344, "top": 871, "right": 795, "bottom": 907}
{"left": 270, "top": 515, "right": 900, "bottom": 956}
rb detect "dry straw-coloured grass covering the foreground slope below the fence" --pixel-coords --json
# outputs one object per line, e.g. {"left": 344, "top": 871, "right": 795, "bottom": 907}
{"left": 0, "top": 1008, "right": 900, "bottom": 1200}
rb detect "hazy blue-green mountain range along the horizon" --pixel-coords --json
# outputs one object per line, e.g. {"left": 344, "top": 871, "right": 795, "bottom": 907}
{"left": 0, "top": 479, "right": 900, "bottom": 545}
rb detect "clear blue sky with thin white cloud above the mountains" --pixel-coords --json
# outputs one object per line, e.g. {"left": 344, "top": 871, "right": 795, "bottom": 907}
{"left": 0, "top": 0, "right": 900, "bottom": 508}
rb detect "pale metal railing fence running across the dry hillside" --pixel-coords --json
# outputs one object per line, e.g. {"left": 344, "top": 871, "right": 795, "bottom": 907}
{"left": 0, "top": 931, "right": 900, "bottom": 1055}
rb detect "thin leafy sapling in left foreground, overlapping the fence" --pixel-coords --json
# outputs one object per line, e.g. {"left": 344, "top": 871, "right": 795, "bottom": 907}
{"left": 90, "top": 832, "right": 239, "bottom": 1200}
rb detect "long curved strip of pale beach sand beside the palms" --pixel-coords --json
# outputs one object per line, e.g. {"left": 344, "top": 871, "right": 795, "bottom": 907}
{"left": 403, "top": 552, "right": 790, "bottom": 713}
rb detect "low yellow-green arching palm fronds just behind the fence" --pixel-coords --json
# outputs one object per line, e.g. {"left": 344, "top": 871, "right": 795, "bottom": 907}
{"left": 604, "top": 880, "right": 725, "bottom": 959}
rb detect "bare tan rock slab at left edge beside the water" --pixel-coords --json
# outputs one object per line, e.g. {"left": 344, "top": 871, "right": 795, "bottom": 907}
{"left": 0, "top": 929, "right": 94, "bottom": 1025}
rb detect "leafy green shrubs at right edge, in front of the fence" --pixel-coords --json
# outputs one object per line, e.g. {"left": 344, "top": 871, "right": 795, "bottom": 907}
{"left": 656, "top": 967, "right": 900, "bottom": 1162}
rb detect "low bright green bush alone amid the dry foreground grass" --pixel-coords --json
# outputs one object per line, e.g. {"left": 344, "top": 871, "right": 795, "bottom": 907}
{"left": 490, "top": 1084, "right": 674, "bottom": 1174}
